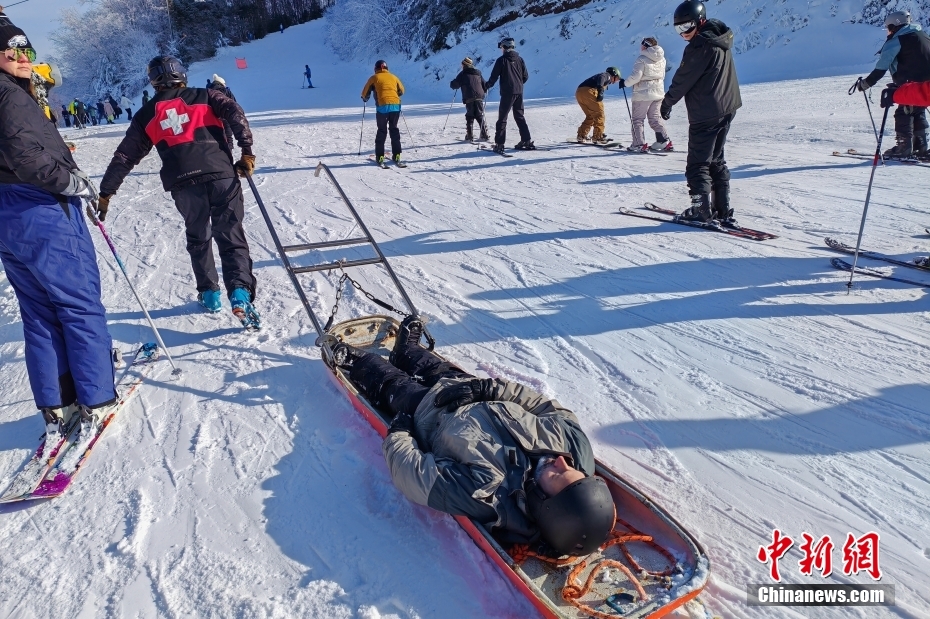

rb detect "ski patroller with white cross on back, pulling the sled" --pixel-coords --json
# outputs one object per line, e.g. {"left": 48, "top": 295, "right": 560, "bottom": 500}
{"left": 99, "top": 56, "right": 260, "bottom": 327}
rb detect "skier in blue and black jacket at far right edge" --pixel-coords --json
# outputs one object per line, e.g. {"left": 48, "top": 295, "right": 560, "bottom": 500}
{"left": 854, "top": 10, "right": 930, "bottom": 159}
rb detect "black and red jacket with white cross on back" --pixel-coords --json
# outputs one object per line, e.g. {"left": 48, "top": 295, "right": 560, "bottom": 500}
{"left": 100, "top": 88, "right": 252, "bottom": 195}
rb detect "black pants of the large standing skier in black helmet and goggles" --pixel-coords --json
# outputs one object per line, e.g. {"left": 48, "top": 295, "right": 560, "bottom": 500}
{"left": 685, "top": 114, "right": 734, "bottom": 196}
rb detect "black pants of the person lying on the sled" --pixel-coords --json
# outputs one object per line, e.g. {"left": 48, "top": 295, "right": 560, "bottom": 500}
{"left": 349, "top": 344, "right": 472, "bottom": 415}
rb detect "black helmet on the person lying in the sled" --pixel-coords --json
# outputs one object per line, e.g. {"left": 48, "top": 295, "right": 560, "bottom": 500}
{"left": 526, "top": 476, "right": 615, "bottom": 556}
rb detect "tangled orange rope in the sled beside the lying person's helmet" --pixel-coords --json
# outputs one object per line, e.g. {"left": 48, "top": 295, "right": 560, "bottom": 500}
{"left": 510, "top": 518, "right": 676, "bottom": 619}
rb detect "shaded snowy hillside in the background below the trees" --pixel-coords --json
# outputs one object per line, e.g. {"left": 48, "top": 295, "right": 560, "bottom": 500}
{"left": 183, "top": 0, "right": 884, "bottom": 112}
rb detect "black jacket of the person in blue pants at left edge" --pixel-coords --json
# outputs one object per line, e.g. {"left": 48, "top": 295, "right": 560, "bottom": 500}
{"left": 0, "top": 72, "right": 78, "bottom": 194}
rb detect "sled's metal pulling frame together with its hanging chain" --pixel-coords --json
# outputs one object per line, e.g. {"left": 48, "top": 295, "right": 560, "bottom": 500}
{"left": 246, "top": 161, "right": 435, "bottom": 352}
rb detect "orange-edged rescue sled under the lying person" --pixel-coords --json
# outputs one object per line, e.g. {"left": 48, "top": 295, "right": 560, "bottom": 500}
{"left": 320, "top": 316, "right": 710, "bottom": 619}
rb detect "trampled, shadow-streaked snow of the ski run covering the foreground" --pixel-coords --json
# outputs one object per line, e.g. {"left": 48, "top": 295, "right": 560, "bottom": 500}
{"left": 0, "top": 70, "right": 930, "bottom": 619}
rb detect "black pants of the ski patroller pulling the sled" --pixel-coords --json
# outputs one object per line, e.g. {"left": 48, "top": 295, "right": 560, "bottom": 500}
{"left": 171, "top": 177, "right": 255, "bottom": 299}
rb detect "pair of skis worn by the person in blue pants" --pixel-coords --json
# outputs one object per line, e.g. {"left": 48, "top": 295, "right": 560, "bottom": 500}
{"left": 0, "top": 343, "right": 160, "bottom": 503}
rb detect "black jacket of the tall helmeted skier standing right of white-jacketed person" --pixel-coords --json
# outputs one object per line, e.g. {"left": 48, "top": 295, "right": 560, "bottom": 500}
{"left": 663, "top": 19, "right": 743, "bottom": 123}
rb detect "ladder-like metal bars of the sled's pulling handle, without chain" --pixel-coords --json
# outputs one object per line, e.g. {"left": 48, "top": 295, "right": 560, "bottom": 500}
{"left": 246, "top": 161, "right": 424, "bottom": 348}
